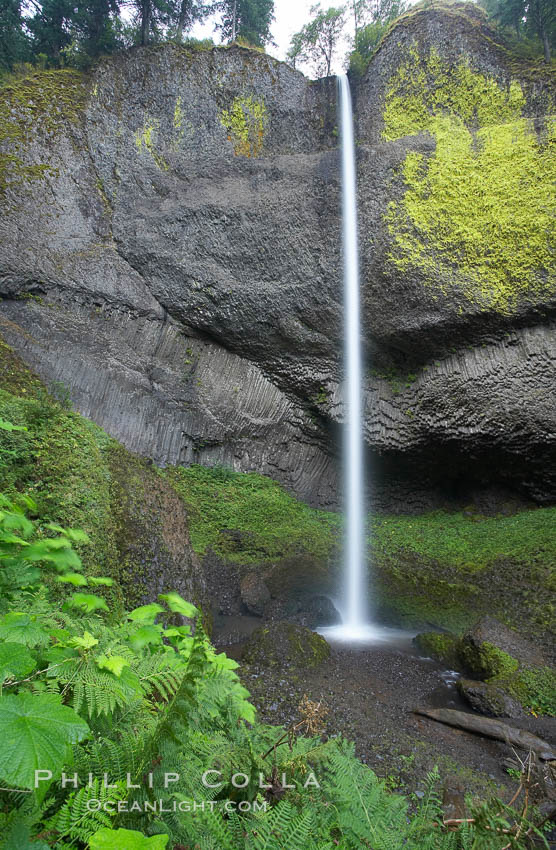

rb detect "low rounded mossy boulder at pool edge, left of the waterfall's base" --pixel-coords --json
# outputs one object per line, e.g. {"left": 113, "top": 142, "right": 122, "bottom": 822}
{"left": 243, "top": 622, "right": 330, "bottom": 668}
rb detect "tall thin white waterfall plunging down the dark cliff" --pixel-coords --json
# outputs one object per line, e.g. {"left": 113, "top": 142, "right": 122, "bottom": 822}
{"left": 338, "top": 74, "right": 367, "bottom": 633}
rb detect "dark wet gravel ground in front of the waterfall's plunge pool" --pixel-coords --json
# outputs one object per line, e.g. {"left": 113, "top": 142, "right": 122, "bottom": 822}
{"left": 218, "top": 620, "right": 556, "bottom": 800}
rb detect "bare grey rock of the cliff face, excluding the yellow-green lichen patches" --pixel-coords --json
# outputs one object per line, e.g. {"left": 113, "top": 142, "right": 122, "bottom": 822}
{"left": 0, "top": 12, "right": 556, "bottom": 510}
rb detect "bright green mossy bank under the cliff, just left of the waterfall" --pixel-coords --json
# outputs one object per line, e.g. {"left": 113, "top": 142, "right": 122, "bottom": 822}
{"left": 166, "top": 465, "right": 339, "bottom": 564}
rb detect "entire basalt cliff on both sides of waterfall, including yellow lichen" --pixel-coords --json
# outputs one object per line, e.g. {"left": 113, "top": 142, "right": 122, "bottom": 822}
{"left": 0, "top": 5, "right": 556, "bottom": 511}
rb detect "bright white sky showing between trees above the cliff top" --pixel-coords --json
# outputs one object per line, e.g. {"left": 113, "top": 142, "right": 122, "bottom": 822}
{"left": 189, "top": 0, "right": 356, "bottom": 76}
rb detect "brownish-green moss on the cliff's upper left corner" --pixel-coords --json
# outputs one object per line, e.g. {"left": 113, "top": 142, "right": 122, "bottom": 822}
{"left": 0, "top": 70, "right": 86, "bottom": 195}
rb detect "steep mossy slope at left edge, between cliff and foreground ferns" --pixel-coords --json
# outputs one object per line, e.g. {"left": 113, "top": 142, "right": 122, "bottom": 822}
{"left": 0, "top": 334, "right": 206, "bottom": 607}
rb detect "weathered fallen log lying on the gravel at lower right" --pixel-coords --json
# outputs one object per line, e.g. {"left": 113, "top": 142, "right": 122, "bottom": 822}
{"left": 413, "top": 708, "right": 556, "bottom": 761}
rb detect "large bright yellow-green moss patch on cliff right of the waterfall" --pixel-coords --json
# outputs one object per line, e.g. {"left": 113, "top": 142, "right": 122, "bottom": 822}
{"left": 383, "top": 48, "right": 556, "bottom": 313}
